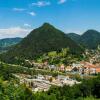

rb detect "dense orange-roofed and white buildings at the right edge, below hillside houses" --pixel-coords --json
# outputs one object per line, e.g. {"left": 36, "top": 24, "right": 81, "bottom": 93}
{"left": 66, "top": 62, "right": 100, "bottom": 75}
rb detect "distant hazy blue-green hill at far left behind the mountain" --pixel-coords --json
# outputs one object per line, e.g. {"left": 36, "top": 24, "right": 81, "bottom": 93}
{"left": 0, "top": 37, "right": 22, "bottom": 52}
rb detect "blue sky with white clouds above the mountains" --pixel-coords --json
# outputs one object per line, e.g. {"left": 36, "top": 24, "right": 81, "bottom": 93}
{"left": 0, "top": 0, "right": 100, "bottom": 38}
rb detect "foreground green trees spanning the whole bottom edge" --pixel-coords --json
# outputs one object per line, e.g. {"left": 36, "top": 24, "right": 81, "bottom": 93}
{"left": 0, "top": 76, "right": 100, "bottom": 100}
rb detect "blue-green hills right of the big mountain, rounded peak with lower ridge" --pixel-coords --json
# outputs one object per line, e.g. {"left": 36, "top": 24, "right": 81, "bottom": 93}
{"left": 68, "top": 29, "right": 100, "bottom": 49}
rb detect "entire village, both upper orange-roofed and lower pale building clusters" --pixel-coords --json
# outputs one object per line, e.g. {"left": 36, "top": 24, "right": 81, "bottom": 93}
{"left": 13, "top": 48, "right": 100, "bottom": 92}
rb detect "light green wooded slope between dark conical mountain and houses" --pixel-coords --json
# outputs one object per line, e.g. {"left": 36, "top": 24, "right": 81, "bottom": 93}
{"left": 36, "top": 48, "right": 83, "bottom": 65}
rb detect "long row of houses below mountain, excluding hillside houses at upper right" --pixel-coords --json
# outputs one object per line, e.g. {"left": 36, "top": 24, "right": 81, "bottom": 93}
{"left": 25, "top": 58, "right": 100, "bottom": 74}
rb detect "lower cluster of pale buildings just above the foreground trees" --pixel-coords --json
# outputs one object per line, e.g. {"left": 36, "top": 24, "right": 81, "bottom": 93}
{"left": 13, "top": 74, "right": 81, "bottom": 92}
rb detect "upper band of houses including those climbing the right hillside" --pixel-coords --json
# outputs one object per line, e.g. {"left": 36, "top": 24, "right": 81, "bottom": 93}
{"left": 23, "top": 47, "right": 100, "bottom": 75}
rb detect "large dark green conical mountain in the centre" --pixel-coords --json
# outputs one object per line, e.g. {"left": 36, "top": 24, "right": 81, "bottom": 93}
{"left": 0, "top": 23, "right": 81, "bottom": 61}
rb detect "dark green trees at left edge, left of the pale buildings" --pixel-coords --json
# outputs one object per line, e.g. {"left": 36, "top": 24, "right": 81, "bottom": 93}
{"left": 0, "top": 62, "right": 32, "bottom": 80}
